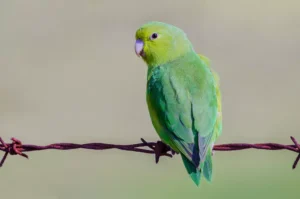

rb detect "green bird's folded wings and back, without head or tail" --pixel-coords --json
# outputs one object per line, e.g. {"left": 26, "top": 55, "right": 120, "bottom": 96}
{"left": 148, "top": 55, "right": 217, "bottom": 167}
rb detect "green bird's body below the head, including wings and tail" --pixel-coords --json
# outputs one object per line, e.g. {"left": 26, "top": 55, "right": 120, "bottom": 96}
{"left": 147, "top": 51, "right": 222, "bottom": 184}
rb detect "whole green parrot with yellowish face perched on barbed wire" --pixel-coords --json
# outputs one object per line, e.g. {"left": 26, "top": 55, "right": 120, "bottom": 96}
{"left": 135, "top": 21, "right": 222, "bottom": 186}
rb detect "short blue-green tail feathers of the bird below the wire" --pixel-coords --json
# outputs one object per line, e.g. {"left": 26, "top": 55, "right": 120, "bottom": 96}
{"left": 181, "top": 149, "right": 212, "bottom": 186}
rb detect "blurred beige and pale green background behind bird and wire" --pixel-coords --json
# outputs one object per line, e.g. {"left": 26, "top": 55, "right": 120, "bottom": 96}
{"left": 0, "top": 0, "right": 300, "bottom": 199}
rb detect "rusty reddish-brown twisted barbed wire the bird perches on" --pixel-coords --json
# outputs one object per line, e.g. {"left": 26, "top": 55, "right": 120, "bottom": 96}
{"left": 0, "top": 137, "right": 300, "bottom": 169}
